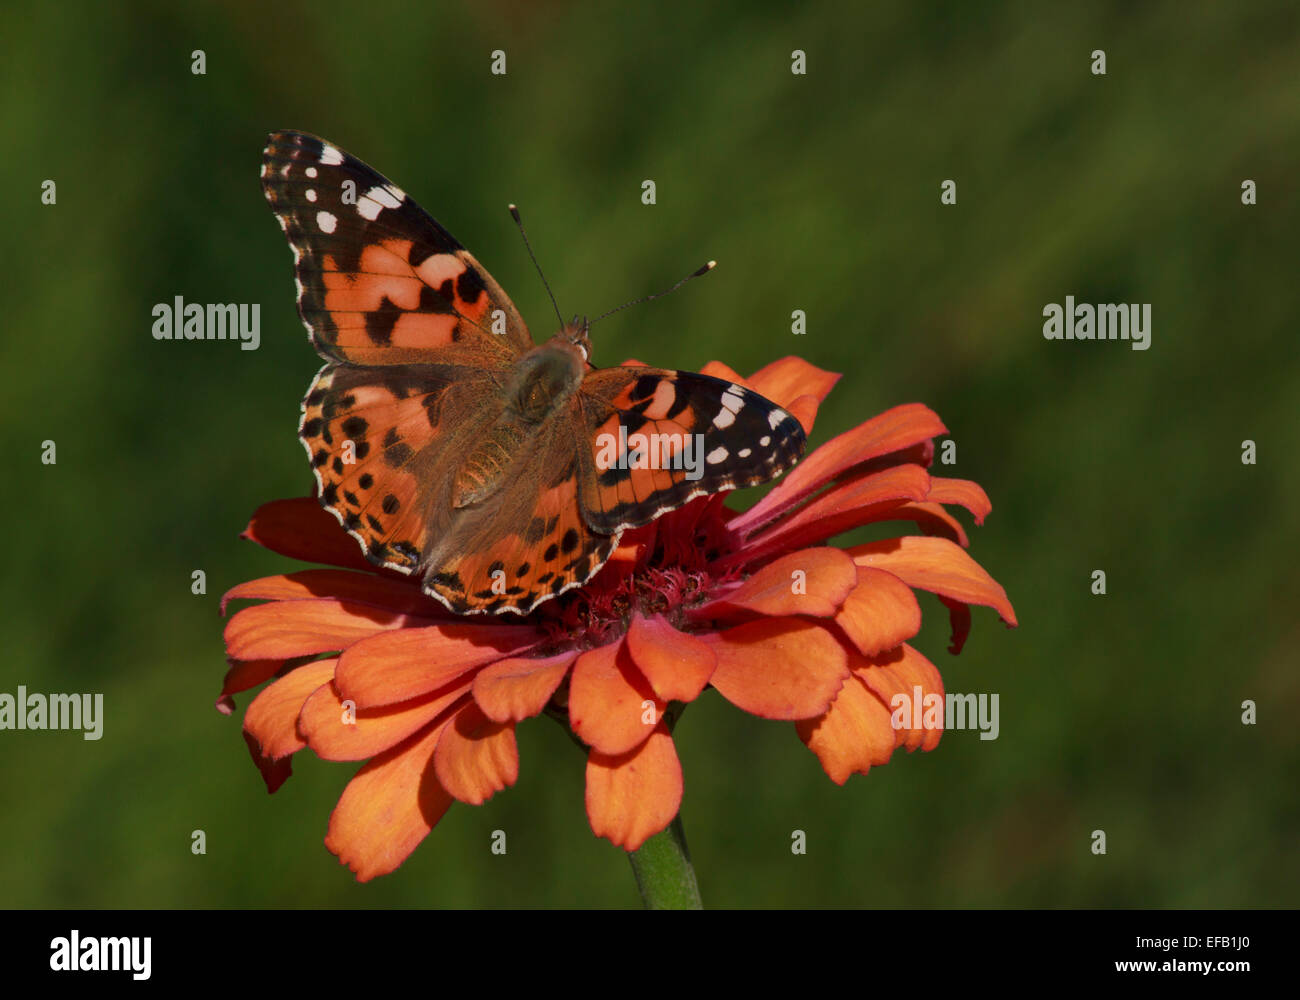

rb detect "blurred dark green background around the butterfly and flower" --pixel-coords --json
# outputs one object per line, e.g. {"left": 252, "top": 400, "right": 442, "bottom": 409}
{"left": 0, "top": 0, "right": 1300, "bottom": 908}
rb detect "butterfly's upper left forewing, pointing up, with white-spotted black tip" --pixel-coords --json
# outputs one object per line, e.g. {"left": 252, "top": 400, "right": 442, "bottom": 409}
{"left": 261, "top": 131, "right": 533, "bottom": 365}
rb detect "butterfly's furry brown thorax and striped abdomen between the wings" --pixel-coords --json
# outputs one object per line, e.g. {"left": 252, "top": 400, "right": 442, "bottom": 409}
{"left": 451, "top": 326, "right": 586, "bottom": 508}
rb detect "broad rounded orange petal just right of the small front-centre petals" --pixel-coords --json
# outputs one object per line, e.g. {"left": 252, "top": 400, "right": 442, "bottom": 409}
{"left": 706, "top": 618, "right": 849, "bottom": 719}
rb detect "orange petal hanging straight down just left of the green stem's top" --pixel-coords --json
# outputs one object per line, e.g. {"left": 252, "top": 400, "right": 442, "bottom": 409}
{"left": 586, "top": 722, "right": 681, "bottom": 850}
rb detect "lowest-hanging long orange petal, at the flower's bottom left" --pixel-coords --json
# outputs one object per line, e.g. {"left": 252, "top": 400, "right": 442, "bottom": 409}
{"left": 325, "top": 723, "right": 454, "bottom": 882}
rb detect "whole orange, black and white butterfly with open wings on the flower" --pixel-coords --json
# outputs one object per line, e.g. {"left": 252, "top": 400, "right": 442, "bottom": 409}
{"left": 261, "top": 131, "right": 806, "bottom": 614}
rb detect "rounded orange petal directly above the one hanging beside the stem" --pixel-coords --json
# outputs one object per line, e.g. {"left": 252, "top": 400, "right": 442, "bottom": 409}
{"left": 569, "top": 637, "right": 667, "bottom": 754}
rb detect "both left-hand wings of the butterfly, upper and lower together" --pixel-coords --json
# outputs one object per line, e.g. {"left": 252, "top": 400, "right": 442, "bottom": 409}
{"left": 261, "top": 131, "right": 533, "bottom": 585}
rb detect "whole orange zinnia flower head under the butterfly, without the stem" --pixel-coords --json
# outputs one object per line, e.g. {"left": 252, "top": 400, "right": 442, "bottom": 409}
{"left": 217, "top": 358, "right": 1015, "bottom": 882}
